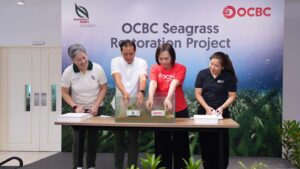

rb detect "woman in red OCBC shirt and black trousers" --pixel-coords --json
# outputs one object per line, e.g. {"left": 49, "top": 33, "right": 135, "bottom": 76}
{"left": 147, "top": 43, "right": 190, "bottom": 169}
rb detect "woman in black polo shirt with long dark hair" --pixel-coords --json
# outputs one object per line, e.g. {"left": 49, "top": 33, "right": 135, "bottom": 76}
{"left": 195, "top": 52, "right": 238, "bottom": 169}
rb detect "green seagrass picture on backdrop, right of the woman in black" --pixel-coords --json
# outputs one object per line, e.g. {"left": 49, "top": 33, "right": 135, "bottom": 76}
{"left": 229, "top": 90, "right": 282, "bottom": 157}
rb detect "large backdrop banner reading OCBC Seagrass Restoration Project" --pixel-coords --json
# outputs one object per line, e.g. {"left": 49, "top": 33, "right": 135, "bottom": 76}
{"left": 62, "top": 0, "right": 285, "bottom": 157}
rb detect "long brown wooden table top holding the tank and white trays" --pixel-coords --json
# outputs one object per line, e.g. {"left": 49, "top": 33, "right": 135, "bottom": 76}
{"left": 55, "top": 116, "right": 240, "bottom": 129}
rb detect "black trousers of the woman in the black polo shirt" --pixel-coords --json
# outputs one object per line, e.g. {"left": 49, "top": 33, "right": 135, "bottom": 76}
{"left": 198, "top": 107, "right": 229, "bottom": 169}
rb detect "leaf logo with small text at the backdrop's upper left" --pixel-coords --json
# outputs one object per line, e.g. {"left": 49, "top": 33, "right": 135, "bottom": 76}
{"left": 73, "top": 3, "right": 95, "bottom": 27}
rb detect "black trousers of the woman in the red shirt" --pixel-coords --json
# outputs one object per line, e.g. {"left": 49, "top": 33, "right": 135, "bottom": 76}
{"left": 155, "top": 108, "right": 190, "bottom": 169}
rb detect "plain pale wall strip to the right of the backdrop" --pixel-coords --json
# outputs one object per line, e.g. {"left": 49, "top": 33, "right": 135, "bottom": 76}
{"left": 283, "top": 0, "right": 300, "bottom": 121}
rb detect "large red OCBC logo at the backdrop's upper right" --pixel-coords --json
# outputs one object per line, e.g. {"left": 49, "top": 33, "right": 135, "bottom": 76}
{"left": 223, "top": 6, "right": 271, "bottom": 19}
